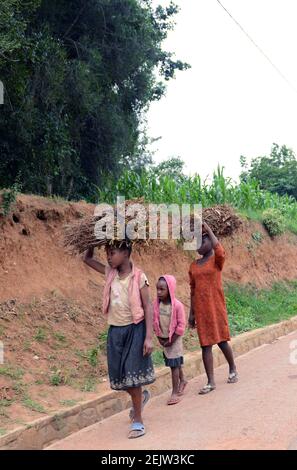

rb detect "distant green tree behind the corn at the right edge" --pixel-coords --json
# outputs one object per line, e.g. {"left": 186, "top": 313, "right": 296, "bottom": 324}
{"left": 241, "top": 143, "right": 297, "bottom": 199}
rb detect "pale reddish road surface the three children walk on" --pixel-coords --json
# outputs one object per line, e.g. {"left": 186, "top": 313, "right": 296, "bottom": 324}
{"left": 46, "top": 332, "right": 297, "bottom": 450}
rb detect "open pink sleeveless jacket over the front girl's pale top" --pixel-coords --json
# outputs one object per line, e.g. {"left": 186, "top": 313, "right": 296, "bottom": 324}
{"left": 103, "top": 263, "right": 144, "bottom": 324}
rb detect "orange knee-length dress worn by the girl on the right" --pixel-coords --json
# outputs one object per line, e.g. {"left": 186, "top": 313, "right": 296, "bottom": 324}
{"left": 189, "top": 243, "right": 230, "bottom": 346}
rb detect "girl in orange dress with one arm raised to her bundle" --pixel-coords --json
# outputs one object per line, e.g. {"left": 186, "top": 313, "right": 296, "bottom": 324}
{"left": 189, "top": 222, "right": 238, "bottom": 395}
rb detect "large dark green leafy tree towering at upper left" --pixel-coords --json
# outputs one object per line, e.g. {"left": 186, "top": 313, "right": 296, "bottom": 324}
{"left": 0, "top": 0, "right": 188, "bottom": 198}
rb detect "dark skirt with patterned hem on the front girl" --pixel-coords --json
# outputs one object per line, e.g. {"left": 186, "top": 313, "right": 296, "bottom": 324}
{"left": 107, "top": 321, "right": 155, "bottom": 390}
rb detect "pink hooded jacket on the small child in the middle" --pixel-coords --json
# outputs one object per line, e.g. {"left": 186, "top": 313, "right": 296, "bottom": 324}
{"left": 154, "top": 274, "right": 186, "bottom": 341}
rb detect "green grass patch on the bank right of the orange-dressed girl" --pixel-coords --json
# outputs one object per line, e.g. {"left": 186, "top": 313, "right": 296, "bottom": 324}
{"left": 225, "top": 281, "right": 297, "bottom": 335}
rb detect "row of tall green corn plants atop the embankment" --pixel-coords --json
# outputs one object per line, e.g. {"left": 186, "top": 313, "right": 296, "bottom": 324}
{"left": 97, "top": 167, "right": 297, "bottom": 233}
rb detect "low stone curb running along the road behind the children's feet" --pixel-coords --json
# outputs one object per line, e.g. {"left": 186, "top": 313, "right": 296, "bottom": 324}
{"left": 0, "top": 316, "right": 297, "bottom": 450}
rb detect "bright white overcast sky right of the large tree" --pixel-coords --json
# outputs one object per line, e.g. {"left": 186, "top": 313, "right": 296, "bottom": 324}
{"left": 148, "top": 0, "right": 297, "bottom": 179}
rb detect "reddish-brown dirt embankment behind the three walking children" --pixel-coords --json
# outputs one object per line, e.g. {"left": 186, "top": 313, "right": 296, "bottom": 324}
{"left": 0, "top": 195, "right": 297, "bottom": 432}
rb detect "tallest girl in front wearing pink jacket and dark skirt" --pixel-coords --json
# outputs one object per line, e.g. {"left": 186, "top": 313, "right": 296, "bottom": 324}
{"left": 84, "top": 240, "right": 155, "bottom": 439}
